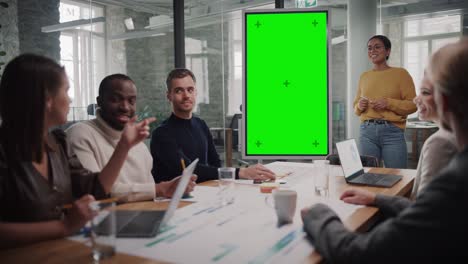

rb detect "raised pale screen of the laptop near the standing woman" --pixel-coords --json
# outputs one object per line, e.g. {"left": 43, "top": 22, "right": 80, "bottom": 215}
{"left": 336, "top": 139, "right": 363, "bottom": 178}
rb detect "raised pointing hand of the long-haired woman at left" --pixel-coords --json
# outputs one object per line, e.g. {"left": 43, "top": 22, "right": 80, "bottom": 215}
{"left": 119, "top": 116, "right": 156, "bottom": 149}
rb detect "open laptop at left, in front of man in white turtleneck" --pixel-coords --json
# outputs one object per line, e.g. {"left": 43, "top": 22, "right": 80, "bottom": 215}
{"left": 96, "top": 159, "right": 198, "bottom": 237}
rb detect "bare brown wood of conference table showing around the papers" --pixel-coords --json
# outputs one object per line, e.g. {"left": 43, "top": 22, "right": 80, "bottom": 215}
{"left": 0, "top": 168, "right": 416, "bottom": 264}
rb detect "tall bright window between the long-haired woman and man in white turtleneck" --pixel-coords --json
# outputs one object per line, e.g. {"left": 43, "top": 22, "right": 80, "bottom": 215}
{"left": 59, "top": 0, "right": 106, "bottom": 120}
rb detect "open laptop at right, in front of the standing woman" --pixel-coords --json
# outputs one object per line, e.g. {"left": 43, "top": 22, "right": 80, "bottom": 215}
{"left": 336, "top": 139, "right": 402, "bottom": 187}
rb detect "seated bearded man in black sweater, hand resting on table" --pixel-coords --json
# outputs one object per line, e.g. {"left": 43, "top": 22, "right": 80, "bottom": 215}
{"left": 151, "top": 69, "right": 275, "bottom": 182}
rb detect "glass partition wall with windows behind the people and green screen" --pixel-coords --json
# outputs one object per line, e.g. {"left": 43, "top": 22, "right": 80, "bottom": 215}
{"left": 0, "top": 0, "right": 468, "bottom": 166}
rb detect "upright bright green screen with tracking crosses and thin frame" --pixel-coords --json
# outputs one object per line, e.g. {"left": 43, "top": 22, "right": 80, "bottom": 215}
{"left": 243, "top": 9, "right": 331, "bottom": 158}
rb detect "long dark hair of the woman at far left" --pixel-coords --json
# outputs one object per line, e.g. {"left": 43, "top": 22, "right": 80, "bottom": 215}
{"left": 0, "top": 54, "right": 66, "bottom": 162}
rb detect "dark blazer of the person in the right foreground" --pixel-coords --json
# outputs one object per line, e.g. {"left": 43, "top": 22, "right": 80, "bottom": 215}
{"left": 304, "top": 148, "right": 468, "bottom": 263}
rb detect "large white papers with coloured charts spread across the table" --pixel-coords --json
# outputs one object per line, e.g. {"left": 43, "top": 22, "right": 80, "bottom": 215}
{"left": 68, "top": 162, "right": 360, "bottom": 263}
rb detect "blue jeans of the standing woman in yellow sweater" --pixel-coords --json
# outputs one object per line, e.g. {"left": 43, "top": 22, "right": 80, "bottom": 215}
{"left": 359, "top": 121, "right": 408, "bottom": 169}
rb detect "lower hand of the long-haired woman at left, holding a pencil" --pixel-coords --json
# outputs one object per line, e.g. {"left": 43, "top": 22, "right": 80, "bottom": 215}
{"left": 63, "top": 194, "right": 95, "bottom": 236}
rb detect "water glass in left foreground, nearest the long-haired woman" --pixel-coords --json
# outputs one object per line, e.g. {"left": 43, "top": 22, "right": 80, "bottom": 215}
{"left": 89, "top": 201, "right": 117, "bottom": 261}
